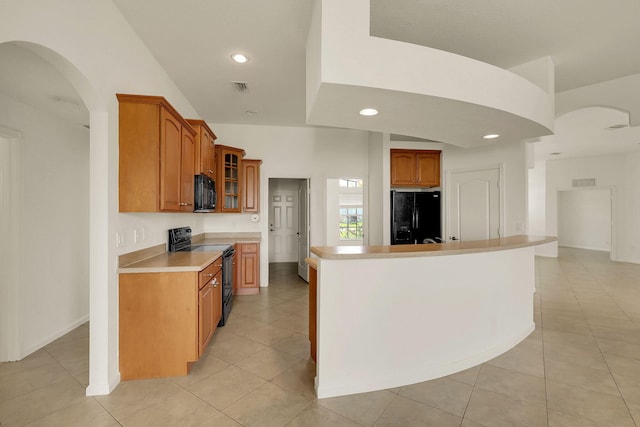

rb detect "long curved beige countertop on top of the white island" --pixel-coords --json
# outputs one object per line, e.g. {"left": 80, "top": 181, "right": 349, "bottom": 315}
{"left": 311, "top": 235, "right": 558, "bottom": 259}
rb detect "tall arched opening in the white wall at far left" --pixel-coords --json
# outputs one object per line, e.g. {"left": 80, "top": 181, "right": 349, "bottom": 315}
{"left": 0, "top": 42, "right": 90, "bottom": 386}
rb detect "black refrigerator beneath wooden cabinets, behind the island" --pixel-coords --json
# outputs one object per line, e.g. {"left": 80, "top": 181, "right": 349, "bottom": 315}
{"left": 391, "top": 190, "right": 442, "bottom": 245}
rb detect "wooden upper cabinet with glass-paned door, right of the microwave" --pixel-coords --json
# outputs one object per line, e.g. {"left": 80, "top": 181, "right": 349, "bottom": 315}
{"left": 216, "top": 145, "right": 245, "bottom": 212}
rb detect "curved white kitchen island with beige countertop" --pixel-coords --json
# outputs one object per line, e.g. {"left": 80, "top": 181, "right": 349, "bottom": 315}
{"left": 310, "top": 236, "right": 556, "bottom": 398}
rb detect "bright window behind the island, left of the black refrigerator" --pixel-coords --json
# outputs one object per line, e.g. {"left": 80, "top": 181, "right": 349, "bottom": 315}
{"left": 339, "top": 179, "right": 364, "bottom": 240}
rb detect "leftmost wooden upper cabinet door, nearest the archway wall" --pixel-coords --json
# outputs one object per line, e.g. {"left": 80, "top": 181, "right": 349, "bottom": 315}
{"left": 160, "top": 108, "right": 182, "bottom": 211}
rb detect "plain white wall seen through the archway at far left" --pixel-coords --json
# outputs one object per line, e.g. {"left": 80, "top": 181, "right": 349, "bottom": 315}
{"left": 0, "top": 94, "right": 89, "bottom": 356}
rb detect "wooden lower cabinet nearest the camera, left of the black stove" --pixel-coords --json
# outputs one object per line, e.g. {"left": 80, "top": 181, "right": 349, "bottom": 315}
{"left": 119, "top": 260, "right": 222, "bottom": 381}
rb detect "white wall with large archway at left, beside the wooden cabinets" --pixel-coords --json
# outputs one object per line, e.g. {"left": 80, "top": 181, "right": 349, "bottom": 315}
{"left": 0, "top": 0, "right": 205, "bottom": 394}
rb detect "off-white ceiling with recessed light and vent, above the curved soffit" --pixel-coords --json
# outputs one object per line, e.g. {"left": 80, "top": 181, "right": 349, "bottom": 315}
{"left": 0, "top": 0, "right": 640, "bottom": 159}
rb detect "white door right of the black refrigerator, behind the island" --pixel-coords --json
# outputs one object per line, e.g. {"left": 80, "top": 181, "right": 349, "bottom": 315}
{"left": 447, "top": 169, "right": 502, "bottom": 241}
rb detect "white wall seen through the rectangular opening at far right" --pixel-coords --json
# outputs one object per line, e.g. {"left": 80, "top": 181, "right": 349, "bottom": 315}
{"left": 558, "top": 189, "right": 611, "bottom": 252}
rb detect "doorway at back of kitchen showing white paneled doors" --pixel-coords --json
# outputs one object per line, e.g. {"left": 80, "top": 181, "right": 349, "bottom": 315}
{"left": 269, "top": 178, "right": 309, "bottom": 282}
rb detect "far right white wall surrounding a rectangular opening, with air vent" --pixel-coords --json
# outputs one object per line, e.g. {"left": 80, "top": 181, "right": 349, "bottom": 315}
{"left": 545, "top": 152, "right": 640, "bottom": 263}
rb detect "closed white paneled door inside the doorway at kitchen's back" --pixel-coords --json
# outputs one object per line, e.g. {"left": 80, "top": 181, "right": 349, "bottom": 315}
{"left": 269, "top": 188, "right": 298, "bottom": 262}
